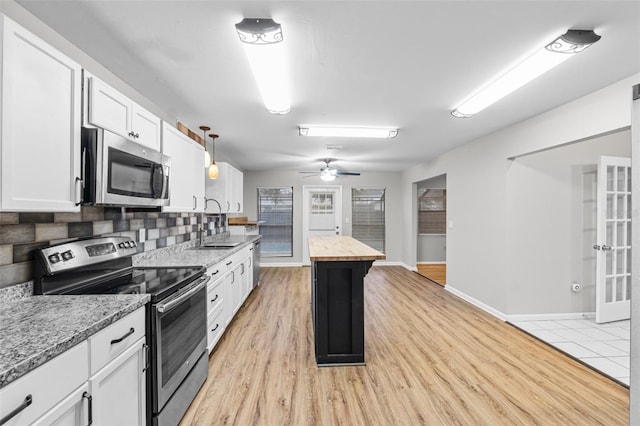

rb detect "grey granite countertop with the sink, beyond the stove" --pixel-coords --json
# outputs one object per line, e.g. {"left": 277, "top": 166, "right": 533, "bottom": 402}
{"left": 133, "top": 235, "right": 262, "bottom": 268}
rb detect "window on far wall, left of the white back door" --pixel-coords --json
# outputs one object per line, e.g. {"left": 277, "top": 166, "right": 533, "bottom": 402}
{"left": 258, "top": 187, "right": 293, "bottom": 257}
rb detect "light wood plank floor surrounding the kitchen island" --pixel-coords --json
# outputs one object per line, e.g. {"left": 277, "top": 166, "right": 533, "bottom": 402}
{"left": 181, "top": 267, "right": 629, "bottom": 426}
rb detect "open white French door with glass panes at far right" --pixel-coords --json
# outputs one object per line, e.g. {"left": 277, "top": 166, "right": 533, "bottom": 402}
{"left": 593, "top": 157, "right": 631, "bottom": 323}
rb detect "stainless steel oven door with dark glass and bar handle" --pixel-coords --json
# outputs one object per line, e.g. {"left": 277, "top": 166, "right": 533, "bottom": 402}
{"left": 152, "top": 277, "right": 208, "bottom": 413}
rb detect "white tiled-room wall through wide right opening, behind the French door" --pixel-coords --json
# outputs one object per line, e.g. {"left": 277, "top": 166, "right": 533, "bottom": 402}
{"left": 505, "top": 130, "right": 631, "bottom": 314}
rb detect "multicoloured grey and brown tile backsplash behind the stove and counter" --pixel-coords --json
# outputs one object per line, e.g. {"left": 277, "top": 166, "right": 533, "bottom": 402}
{"left": 0, "top": 206, "right": 226, "bottom": 288}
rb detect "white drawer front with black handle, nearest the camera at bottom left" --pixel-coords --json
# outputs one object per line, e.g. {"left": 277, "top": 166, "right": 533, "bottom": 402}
{"left": 0, "top": 341, "right": 89, "bottom": 425}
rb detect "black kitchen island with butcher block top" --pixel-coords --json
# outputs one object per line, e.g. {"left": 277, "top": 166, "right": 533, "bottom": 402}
{"left": 309, "top": 236, "right": 386, "bottom": 366}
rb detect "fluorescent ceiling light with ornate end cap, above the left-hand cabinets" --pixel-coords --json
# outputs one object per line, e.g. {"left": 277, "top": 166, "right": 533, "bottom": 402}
{"left": 236, "top": 18, "right": 291, "bottom": 114}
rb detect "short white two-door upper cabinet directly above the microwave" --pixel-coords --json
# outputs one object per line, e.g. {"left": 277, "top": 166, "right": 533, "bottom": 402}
{"left": 86, "top": 74, "right": 161, "bottom": 151}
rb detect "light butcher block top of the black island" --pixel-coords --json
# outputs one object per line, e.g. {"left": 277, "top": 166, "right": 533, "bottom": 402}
{"left": 309, "top": 236, "right": 387, "bottom": 262}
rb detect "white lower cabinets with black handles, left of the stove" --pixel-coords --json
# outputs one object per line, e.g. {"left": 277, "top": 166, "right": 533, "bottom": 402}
{"left": 0, "top": 307, "right": 146, "bottom": 426}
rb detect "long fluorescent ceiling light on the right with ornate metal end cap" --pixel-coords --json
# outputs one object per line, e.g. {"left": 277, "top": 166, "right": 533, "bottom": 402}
{"left": 451, "top": 30, "right": 600, "bottom": 118}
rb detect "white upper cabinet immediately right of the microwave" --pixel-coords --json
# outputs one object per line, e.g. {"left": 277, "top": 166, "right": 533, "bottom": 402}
{"left": 162, "top": 122, "right": 204, "bottom": 213}
